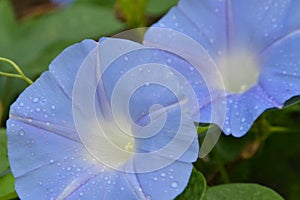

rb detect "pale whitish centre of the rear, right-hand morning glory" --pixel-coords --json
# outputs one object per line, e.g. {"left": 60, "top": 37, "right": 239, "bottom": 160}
{"left": 217, "top": 50, "right": 259, "bottom": 93}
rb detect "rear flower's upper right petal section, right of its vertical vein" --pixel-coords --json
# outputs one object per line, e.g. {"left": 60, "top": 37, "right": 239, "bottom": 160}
{"left": 229, "top": 0, "right": 300, "bottom": 52}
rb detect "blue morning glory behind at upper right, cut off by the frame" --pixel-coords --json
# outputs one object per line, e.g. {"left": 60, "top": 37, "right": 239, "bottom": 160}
{"left": 144, "top": 0, "right": 300, "bottom": 137}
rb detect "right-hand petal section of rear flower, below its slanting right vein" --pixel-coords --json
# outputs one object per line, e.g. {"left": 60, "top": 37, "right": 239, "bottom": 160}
{"left": 260, "top": 30, "right": 300, "bottom": 104}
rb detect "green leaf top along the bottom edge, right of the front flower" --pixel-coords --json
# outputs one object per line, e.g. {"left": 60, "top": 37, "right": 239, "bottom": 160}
{"left": 204, "top": 183, "right": 283, "bottom": 200}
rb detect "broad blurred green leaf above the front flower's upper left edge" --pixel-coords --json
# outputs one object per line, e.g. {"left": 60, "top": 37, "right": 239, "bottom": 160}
{"left": 14, "top": 4, "right": 124, "bottom": 75}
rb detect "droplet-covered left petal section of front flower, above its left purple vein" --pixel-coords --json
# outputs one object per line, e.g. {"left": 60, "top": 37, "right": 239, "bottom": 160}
{"left": 10, "top": 72, "right": 78, "bottom": 140}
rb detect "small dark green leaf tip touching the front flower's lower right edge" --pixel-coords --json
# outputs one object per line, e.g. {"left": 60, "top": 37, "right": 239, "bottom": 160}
{"left": 176, "top": 168, "right": 206, "bottom": 200}
